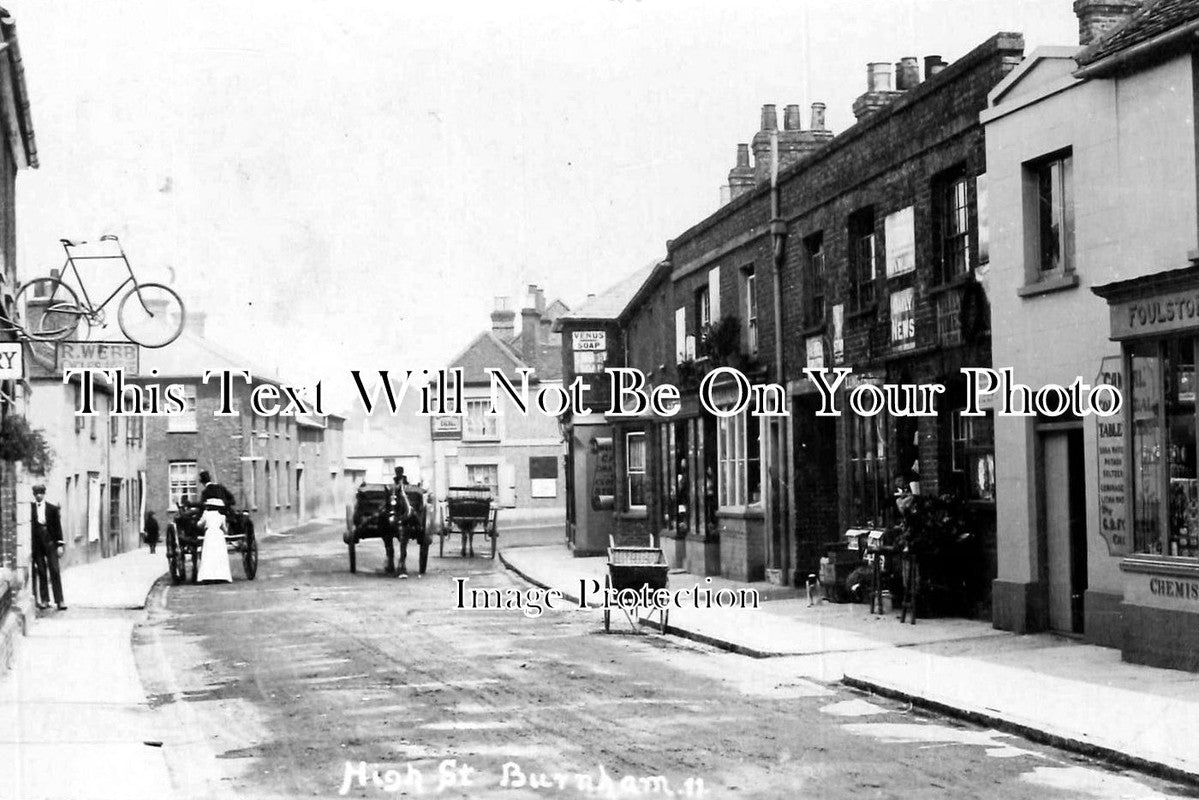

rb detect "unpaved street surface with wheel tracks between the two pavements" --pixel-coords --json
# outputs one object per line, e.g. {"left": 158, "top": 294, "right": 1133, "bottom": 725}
{"left": 134, "top": 523, "right": 1199, "bottom": 800}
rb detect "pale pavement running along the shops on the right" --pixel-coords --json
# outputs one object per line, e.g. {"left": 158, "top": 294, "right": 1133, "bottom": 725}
{"left": 500, "top": 540, "right": 1199, "bottom": 783}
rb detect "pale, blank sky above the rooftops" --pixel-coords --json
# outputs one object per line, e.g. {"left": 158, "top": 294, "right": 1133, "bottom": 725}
{"left": 5, "top": 0, "right": 1078, "bottom": 397}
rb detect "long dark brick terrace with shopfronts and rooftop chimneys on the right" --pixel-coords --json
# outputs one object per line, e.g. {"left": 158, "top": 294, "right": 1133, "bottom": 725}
{"left": 580, "top": 34, "right": 1023, "bottom": 614}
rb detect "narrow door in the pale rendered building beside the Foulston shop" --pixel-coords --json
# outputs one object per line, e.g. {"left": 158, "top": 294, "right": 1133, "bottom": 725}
{"left": 1041, "top": 428, "right": 1086, "bottom": 633}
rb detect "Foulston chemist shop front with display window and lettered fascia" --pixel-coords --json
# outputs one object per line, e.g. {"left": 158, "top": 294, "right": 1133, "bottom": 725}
{"left": 1093, "top": 266, "right": 1199, "bottom": 670}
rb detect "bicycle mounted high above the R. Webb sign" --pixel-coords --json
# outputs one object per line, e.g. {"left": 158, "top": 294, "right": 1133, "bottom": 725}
{"left": 5, "top": 234, "right": 186, "bottom": 348}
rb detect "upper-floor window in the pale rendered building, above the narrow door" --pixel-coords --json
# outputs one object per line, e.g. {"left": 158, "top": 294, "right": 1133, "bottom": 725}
{"left": 1025, "top": 151, "right": 1074, "bottom": 281}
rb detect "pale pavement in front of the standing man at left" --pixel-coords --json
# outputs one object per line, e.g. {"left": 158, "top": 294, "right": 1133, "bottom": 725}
{"left": 0, "top": 547, "right": 173, "bottom": 800}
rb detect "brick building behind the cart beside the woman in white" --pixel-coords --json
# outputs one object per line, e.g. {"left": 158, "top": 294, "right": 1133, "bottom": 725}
{"left": 137, "top": 313, "right": 348, "bottom": 533}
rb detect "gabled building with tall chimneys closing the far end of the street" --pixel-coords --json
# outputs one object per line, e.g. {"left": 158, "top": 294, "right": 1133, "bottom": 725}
{"left": 427, "top": 285, "right": 568, "bottom": 521}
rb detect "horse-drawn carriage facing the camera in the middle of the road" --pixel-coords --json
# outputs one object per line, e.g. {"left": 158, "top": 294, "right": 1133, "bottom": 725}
{"left": 342, "top": 483, "right": 429, "bottom": 576}
